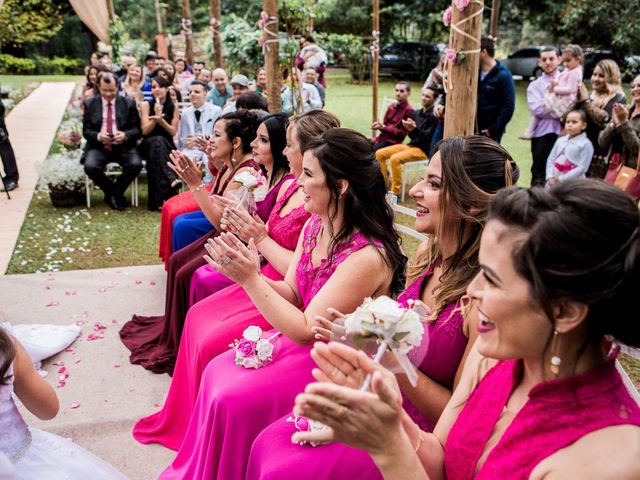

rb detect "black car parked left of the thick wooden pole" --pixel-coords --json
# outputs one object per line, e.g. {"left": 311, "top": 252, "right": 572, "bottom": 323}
{"left": 379, "top": 42, "right": 441, "bottom": 80}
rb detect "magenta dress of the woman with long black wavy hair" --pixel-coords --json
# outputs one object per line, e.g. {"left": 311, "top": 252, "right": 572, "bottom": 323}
{"left": 159, "top": 216, "right": 379, "bottom": 480}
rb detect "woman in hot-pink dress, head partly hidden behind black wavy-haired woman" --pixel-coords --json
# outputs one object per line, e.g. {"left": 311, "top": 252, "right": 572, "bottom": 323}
{"left": 133, "top": 110, "right": 339, "bottom": 450}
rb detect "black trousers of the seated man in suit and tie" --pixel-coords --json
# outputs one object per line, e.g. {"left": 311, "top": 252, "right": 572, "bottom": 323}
{"left": 84, "top": 145, "right": 142, "bottom": 198}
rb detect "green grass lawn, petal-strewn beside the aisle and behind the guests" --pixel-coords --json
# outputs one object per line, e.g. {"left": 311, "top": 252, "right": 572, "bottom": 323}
{"left": 6, "top": 71, "right": 531, "bottom": 273}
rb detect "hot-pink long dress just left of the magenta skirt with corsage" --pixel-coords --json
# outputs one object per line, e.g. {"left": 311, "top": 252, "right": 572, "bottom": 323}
{"left": 133, "top": 182, "right": 309, "bottom": 450}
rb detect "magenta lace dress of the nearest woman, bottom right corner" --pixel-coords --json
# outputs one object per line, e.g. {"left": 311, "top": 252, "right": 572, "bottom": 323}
{"left": 444, "top": 360, "right": 640, "bottom": 480}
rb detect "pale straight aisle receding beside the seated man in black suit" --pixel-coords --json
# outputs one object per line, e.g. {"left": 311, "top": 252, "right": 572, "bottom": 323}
{"left": 0, "top": 82, "right": 74, "bottom": 275}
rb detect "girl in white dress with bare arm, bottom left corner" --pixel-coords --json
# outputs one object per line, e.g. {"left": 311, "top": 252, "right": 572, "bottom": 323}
{"left": 0, "top": 328, "right": 126, "bottom": 480}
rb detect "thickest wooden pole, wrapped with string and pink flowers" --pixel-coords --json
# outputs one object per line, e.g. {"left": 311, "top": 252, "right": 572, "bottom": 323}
{"left": 444, "top": 0, "right": 484, "bottom": 138}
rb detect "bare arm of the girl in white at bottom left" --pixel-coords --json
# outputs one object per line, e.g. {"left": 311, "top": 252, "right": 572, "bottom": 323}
{"left": 13, "top": 339, "right": 60, "bottom": 420}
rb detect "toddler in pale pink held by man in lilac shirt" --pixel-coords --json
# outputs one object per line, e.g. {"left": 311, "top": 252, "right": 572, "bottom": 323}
{"left": 520, "top": 45, "right": 584, "bottom": 140}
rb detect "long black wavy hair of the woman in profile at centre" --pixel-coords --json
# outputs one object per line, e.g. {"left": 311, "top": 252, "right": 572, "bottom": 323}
{"left": 303, "top": 128, "right": 407, "bottom": 294}
